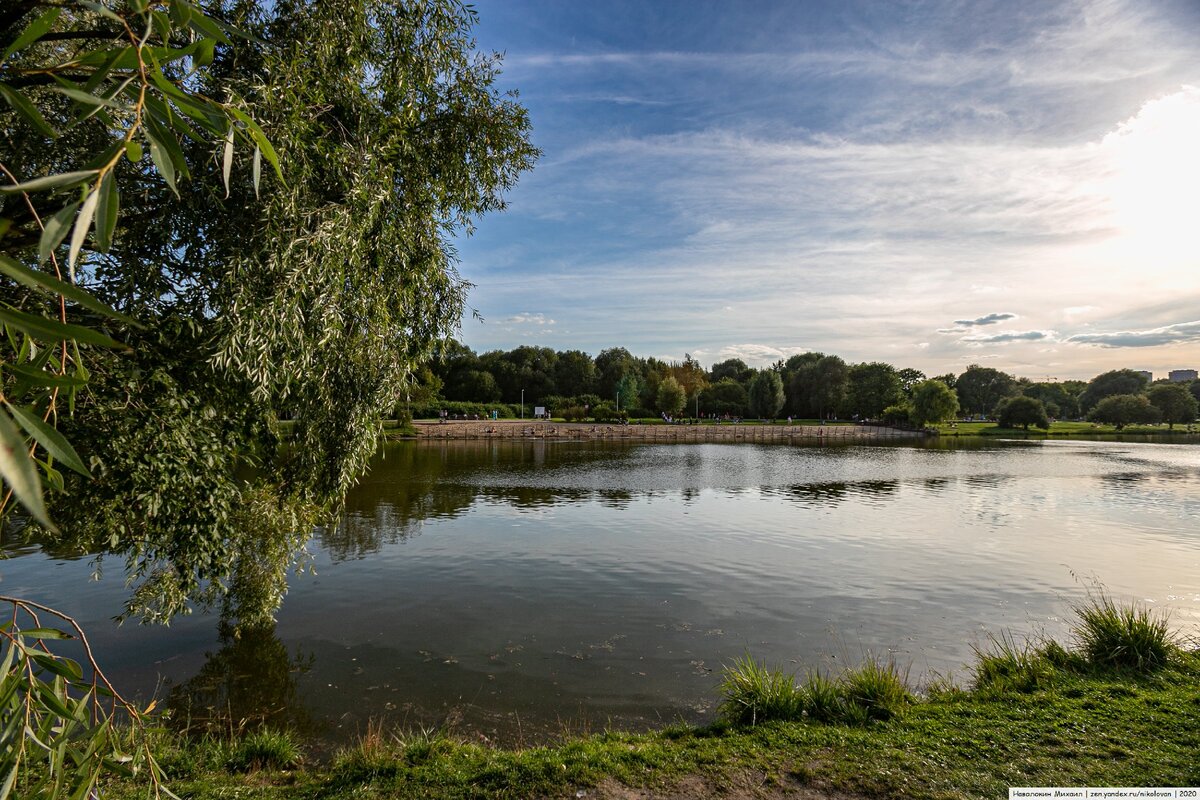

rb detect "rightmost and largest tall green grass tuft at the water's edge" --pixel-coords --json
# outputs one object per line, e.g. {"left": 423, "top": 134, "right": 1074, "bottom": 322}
{"left": 1074, "top": 596, "right": 1178, "bottom": 673}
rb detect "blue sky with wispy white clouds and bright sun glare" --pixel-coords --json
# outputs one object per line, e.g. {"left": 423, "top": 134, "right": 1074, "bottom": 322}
{"left": 457, "top": 0, "right": 1200, "bottom": 379}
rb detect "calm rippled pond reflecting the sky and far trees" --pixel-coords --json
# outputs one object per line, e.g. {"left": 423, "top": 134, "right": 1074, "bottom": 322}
{"left": 0, "top": 439, "right": 1200, "bottom": 744}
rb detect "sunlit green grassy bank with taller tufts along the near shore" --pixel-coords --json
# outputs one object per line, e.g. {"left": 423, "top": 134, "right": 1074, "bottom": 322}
{"left": 106, "top": 600, "right": 1200, "bottom": 799}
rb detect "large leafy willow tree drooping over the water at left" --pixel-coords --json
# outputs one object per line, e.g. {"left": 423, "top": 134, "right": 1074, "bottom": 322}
{"left": 0, "top": 0, "right": 536, "bottom": 619}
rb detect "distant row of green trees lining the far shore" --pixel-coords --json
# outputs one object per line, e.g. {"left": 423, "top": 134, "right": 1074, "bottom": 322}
{"left": 403, "top": 339, "right": 1200, "bottom": 428}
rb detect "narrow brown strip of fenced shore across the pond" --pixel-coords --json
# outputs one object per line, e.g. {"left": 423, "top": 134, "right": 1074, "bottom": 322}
{"left": 413, "top": 420, "right": 924, "bottom": 441}
